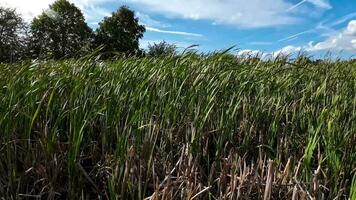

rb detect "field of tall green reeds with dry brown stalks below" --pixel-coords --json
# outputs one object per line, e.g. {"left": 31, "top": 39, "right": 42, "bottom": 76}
{"left": 0, "top": 53, "right": 356, "bottom": 200}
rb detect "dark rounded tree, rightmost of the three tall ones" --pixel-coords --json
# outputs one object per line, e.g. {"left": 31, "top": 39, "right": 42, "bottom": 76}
{"left": 95, "top": 6, "right": 146, "bottom": 54}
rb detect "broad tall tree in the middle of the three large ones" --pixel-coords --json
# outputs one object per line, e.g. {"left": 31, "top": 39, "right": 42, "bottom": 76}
{"left": 31, "top": 0, "right": 92, "bottom": 59}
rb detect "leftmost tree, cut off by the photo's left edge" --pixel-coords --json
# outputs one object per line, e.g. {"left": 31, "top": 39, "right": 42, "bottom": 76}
{"left": 0, "top": 7, "right": 26, "bottom": 62}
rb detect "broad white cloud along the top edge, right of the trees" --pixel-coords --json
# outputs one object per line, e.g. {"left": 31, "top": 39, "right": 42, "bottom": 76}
{"left": 130, "top": 0, "right": 299, "bottom": 27}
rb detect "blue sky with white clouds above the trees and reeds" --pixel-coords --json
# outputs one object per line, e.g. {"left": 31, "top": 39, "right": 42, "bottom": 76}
{"left": 0, "top": 0, "right": 356, "bottom": 58}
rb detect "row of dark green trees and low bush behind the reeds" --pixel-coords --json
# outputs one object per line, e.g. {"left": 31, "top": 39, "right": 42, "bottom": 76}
{"left": 0, "top": 0, "right": 175, "bottom": 62}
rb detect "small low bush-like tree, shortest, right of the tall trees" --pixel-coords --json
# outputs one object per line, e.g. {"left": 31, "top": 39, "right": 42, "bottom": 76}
{"left": 147, "top": 41, "right": 177, "bottom": 57}
